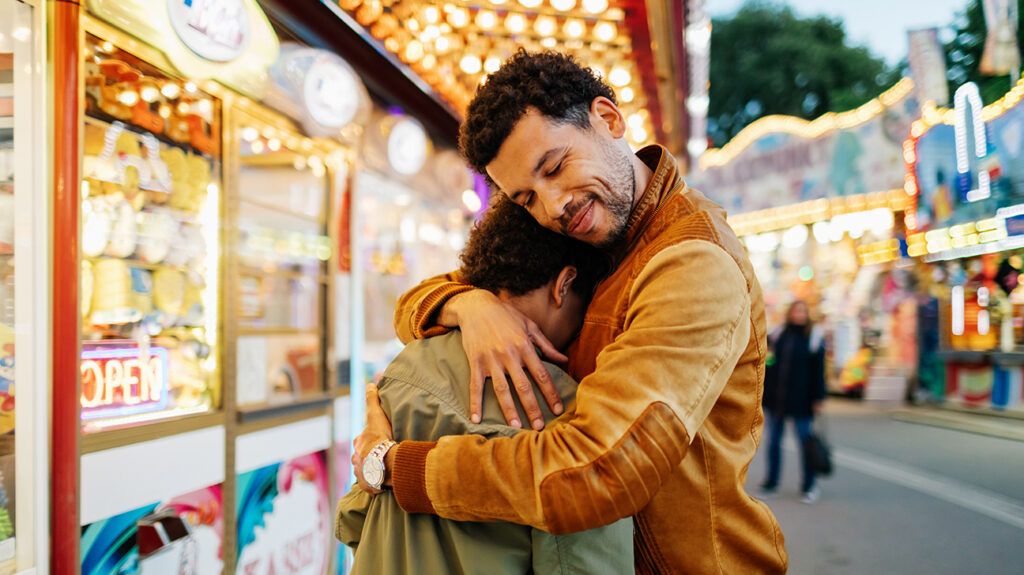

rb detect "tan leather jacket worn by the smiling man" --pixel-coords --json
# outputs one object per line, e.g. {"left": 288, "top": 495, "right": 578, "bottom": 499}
{"left": 392, "top": 146, "right": 787, "bottom": 575}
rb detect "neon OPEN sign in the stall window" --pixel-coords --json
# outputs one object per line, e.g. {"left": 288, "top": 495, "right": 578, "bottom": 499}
{"left": 81, "top": 341, "right": 169, "bottom": 419}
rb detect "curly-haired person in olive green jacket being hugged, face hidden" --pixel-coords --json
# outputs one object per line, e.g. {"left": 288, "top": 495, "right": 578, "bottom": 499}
{"left": 336, "top": 194, "right": 633, "bottom": 575}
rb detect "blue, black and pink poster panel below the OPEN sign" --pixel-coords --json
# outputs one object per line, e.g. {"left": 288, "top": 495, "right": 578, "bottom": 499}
{"left": 82, "top": 485, "right": 224, "bottom": 575}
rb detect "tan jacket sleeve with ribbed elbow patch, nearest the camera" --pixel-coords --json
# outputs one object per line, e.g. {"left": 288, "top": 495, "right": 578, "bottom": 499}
{"left": 392, "top": 240, "right": 751, "bottom": 534}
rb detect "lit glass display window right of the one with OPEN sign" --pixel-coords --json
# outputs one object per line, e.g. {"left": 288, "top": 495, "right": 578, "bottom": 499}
{"left": 227, "top": 106, "right": 338, "bottom": 412}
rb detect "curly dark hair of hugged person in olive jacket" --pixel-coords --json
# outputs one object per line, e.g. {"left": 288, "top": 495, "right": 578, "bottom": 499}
{"left": 459, "top": 196, "right": 608, "bottom": 298}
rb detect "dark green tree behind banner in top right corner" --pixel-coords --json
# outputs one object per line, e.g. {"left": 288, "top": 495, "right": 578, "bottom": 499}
{"left": 945, "top": 0, "right": 1024, "bottom": 103}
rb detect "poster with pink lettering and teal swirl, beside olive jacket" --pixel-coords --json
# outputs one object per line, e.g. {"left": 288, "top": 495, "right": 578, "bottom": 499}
{"left": 236, "top": 451, "right": 334, "bottom": 575}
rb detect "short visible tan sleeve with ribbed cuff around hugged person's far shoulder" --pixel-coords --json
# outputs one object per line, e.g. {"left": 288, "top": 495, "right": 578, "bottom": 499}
{"left": 394, "top": 272, "right": 473, "bottom": 344}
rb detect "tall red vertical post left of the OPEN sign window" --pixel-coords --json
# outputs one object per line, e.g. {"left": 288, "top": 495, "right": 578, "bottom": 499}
{"left": 50, "top": 0, "right": 81, "bottom": 575}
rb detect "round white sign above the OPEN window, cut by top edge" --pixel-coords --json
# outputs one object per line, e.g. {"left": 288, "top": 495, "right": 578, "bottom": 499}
{"left": 167, "top": 0, "right": 249, "bottom": 61}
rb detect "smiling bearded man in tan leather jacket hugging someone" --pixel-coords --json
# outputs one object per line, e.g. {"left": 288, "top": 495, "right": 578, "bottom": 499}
{"left": 355, "top": 52, "right": 786, "bottom": 574}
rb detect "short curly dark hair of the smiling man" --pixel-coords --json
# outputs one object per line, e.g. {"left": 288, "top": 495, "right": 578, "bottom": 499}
{"left": 459, "top": 48, "right": 615, "bottom": 174}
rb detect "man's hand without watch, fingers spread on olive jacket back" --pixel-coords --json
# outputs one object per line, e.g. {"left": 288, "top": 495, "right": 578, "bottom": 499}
{"left": 439, "top": 290, "right": 567, "bottom": 430}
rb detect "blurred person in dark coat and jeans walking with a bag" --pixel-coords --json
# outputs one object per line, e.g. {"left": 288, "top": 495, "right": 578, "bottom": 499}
{"left": 761, "top": 300, "right": 825, "bottom": 503}
